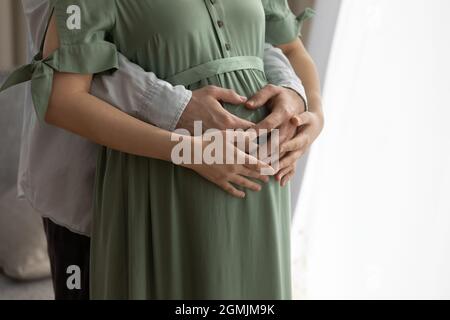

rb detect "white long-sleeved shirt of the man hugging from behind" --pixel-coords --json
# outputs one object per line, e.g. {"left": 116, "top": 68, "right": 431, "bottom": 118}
{"left": 18, "top": 0, "right": 306, "bottom": 235}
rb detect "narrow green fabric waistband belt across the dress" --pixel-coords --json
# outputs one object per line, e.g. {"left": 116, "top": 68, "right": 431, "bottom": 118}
{"left": 165, "top": 56, "right": 264, "bottom": 87}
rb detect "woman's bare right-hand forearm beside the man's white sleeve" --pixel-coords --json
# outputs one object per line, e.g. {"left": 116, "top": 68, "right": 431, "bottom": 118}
{"left": 278, "top": 38, "right": 322, "bottom": 115}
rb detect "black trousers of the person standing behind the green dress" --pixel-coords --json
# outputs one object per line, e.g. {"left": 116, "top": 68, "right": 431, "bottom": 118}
{"left": 43, "top": 218, "right": 91, "bottom": 300}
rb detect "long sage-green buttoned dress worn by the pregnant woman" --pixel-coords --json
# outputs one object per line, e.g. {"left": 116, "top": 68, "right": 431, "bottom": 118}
{"left": 0, "top": 0, "right": 311, "bottom": 299}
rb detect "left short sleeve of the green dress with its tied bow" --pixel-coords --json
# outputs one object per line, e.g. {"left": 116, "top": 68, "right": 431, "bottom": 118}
{"left": 0, "top": 0, "right": 119, "bottom": 121}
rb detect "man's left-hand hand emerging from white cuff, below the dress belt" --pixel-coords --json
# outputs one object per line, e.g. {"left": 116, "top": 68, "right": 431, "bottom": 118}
{"left": 177, "top": 86, "right": 254, "bottom": 134}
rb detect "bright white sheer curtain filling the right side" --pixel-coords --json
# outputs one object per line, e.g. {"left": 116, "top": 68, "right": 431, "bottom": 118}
{"left": 293, "top": 0, "right": 450, "bottom": 299}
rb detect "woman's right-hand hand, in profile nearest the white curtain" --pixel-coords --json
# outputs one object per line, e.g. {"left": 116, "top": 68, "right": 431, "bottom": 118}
{"left": 275, "top": 112, "right": 324, "bottom": 187}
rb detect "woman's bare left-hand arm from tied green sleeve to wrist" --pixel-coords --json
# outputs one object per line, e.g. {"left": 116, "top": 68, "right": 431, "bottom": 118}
{"left": 44, "top": 17, "right": 176, "bottom": 161}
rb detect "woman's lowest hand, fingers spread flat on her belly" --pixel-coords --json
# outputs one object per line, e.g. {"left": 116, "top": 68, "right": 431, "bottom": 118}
{"left": 183, "top": 132, "right": 275, "bottom": 198}
